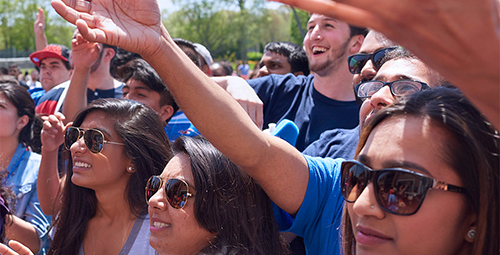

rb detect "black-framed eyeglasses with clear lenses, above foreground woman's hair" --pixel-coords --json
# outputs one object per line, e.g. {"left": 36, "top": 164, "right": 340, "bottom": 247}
{"left": 356, "top": 80, "right": 430, "bottom": 100}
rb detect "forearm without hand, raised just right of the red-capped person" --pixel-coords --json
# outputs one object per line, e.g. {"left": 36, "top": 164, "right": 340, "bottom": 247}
{"left": 62, "top": 67, "right": 90, "bottom": 124}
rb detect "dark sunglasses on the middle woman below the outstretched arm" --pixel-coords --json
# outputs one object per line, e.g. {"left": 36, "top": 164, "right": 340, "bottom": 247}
{"left": 146, "top": 175, "right": 194, "bottom": 209}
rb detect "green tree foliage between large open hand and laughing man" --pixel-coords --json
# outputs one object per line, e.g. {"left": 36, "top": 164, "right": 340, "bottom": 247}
{"left": 164, "top": 0, "right": 291, "bottom": 60}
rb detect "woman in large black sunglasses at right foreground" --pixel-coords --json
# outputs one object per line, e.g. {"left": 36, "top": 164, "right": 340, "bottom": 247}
{"left": 340, "top": 88, "right": 500, "bottom": 254}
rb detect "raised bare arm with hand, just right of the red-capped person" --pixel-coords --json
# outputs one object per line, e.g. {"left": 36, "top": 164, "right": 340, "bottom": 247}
{"left": 62, "top": 34, "right": 100, "bottom": 123}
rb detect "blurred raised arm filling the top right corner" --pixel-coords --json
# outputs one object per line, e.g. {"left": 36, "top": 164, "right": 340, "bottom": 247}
{"left": 273, "top": 0, "right": 500, "bottom": 128}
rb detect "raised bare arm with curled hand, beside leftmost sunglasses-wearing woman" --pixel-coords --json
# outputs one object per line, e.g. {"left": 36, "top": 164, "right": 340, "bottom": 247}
{"left": 37, "top": 113, "right": 70, "bottom": 215}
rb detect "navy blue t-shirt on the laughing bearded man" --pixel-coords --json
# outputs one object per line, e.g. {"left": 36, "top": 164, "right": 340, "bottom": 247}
{"left": 247, "top": 74, "right": 359, "bottom": 151}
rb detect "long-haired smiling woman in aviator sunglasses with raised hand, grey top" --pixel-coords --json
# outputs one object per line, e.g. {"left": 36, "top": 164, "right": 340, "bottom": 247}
{"left": 39, "top": 99, "right": 171, "bottom": 254}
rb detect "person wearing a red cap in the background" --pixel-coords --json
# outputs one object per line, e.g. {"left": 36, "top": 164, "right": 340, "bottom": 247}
{"left": 30, "top": 44, "right": 71, "bottom": 105}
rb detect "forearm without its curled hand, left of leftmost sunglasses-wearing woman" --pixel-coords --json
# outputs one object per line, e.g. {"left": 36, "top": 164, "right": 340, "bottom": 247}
{"left": 37, "top": 146, "right": 62, "bottom": 215}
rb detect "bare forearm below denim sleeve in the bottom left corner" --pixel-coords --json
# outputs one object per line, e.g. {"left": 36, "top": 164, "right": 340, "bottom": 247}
{"left": 5, "top": 215, "right": 40, "bottom": 253}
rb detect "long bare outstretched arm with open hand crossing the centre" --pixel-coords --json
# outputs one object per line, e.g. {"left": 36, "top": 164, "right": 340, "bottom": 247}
{"left": 52, "top": 0, "right": 309, "bottom": 214}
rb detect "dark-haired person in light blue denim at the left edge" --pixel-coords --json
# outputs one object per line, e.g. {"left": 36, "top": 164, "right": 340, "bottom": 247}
{"left": 0, "top": 78, "right": 50, "bottom": 254}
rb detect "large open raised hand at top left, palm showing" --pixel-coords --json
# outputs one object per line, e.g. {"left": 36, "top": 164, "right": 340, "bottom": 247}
{"left": 52, "top": 0, "right": 166, "bottom": 56}
